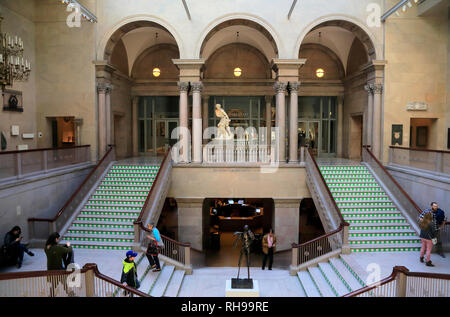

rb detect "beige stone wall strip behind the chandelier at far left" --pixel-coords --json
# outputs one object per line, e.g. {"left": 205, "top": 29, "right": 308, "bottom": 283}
{"left": 0, "top": 0, "right": 38, "bottom": 151}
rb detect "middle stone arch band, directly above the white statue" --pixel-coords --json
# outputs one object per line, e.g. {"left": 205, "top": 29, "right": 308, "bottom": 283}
{"left": 195, "top": 14, "right": 284, "bottom": 58}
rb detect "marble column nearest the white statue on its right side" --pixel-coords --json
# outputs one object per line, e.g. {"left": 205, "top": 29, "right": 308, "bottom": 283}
{"left": 274, "top": 82, "right": 287, "bottom": 162}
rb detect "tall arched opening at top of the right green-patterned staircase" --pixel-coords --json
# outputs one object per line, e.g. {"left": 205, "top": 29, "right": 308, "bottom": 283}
{"left": 298, "top": 20, "right": 376, "bottom": 160}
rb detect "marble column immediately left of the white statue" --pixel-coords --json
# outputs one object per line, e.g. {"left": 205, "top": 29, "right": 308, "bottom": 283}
{"left": 191, "top": 82, "right": 203, "bottom": 163}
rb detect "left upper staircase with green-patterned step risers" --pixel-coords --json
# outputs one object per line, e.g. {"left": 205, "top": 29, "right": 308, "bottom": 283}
{"left": 61, "top": 163, "right": 159, "bottom": 250}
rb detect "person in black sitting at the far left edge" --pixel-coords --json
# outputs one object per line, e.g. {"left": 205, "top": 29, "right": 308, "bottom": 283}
{"left": 2, "top": 226, "right": 34, "bottom": 269}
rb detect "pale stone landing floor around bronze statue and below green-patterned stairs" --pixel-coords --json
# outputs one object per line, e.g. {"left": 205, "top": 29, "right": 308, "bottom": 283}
{"left": 0, "top": 249, "right": 450, "bottom": 297}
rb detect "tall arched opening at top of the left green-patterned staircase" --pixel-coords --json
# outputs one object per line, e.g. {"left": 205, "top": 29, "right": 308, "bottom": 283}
{"left": 103, "top": 21, "right": 180, "bottom": 157}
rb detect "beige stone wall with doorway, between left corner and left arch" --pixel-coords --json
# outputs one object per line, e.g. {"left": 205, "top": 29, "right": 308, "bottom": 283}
{"left": 35, "top": 0, "right": 97, "bottom": 160}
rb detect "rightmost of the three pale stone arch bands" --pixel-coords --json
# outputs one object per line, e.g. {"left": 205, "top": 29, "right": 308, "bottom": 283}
{"left": 294, "top": 15, "right": 382, "bottom": 60}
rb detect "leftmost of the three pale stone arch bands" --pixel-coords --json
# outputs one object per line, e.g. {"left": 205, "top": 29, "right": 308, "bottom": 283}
{"left": 97, "top": 15, "right": 184, "bottom": 62}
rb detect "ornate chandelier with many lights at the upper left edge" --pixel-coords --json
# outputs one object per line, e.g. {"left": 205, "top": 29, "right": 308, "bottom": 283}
{"left": 0, "top": 16, "right": 31, "bottom": 91}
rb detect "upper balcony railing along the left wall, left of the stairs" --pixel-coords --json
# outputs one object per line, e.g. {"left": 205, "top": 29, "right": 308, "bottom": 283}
{"left": 0, "top": 145, "right": 91, "bottom": 183}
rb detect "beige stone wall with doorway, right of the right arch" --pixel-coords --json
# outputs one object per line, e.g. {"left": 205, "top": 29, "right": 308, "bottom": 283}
{"left": 383, "top": 10, "right": 449, "bottom": 161}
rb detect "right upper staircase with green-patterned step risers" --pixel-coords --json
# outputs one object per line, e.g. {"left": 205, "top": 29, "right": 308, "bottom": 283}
{"left": 319, "top": 164, "right": 421, "bottom": 252}
